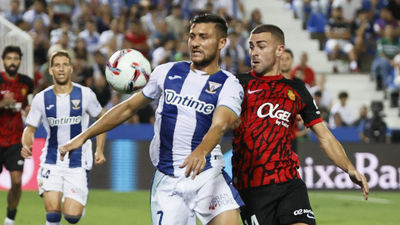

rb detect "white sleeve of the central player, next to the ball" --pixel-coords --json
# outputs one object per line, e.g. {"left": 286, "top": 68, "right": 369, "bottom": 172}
{"left": 142, "top": 63, "right": 173, "bottom": 99}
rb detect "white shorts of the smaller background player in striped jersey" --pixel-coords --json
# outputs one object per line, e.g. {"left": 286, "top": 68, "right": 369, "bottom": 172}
{"left": 37, "top": 164, "right": 89, "bottom": 206}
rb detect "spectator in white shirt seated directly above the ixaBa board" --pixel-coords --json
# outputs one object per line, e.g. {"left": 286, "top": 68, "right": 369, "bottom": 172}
{"left": 329, "top": 91, "right": 356, "bottom": 129}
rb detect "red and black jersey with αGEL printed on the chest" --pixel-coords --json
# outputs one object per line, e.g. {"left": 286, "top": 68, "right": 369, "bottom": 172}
{"left": 232, "top": 72, "right": 322, "bottom": 189}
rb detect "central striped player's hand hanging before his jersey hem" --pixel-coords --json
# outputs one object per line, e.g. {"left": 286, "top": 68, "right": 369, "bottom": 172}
{"left": 179, "top": 149, "right": 206, "bottom": 179}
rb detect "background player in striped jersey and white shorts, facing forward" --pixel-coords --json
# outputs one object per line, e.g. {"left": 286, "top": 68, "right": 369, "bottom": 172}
{"left": 21, "top": 51, "right": 105, "bottom": 225}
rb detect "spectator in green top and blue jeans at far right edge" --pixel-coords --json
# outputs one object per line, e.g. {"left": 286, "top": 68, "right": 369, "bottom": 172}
{"left": 371, "top": 25, "right": 400, "bottom": 90}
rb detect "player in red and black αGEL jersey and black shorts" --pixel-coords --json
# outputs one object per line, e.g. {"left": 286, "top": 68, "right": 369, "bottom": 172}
{"left": 232, "top": 25, "right": 369, "bottom": 225}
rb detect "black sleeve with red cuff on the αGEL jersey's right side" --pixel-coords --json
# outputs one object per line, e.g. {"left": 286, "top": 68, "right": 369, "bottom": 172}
{"left": 300, "top": 86, "right": 322, "bottom": 127}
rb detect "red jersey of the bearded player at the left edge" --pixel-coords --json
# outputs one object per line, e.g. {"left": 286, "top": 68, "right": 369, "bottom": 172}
{"left": 0, "top": 72, "right": 33, "bottom": 147}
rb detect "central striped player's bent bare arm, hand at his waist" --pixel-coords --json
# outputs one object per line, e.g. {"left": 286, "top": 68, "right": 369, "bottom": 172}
{"left": 180, "top": 106, "right": 237, "bottom": 179}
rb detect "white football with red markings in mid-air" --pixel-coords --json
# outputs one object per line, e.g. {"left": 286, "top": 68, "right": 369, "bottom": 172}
{"left": 106, "top": 49, "right": 151, "bottom": 94}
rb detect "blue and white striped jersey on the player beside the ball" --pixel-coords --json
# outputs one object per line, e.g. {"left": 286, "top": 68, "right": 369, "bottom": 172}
{"left": 143, "top": 62, "right": 243, "bottom": 176}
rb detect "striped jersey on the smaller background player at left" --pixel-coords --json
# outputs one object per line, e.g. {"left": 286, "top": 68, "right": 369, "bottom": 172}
{"left": 26, "top": 83, "right": 102, "bottom": 170}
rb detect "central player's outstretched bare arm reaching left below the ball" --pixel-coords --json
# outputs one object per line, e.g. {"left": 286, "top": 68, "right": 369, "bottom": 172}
{"left": 59, "top": 92, "right": 152, "bottom": 160}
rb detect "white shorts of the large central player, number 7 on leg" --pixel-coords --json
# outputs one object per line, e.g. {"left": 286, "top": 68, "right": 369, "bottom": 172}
{"left": 151, "top": 168, "right": 243, "bottom": 225}
